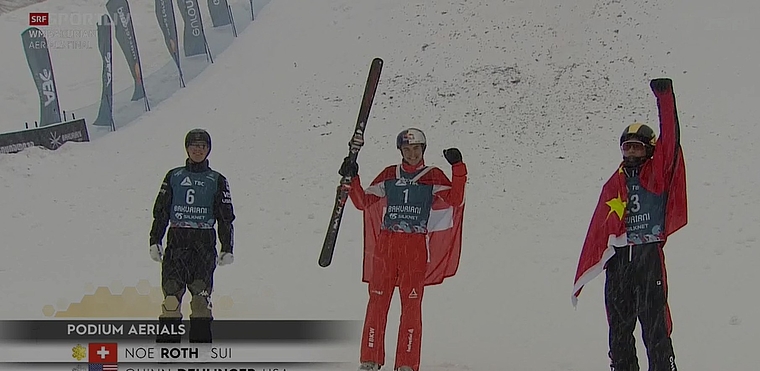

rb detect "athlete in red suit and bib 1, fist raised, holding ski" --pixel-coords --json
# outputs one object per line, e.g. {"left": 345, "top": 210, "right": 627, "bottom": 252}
{"left": 339, "top": 129, "right": 467, "bottom": 371}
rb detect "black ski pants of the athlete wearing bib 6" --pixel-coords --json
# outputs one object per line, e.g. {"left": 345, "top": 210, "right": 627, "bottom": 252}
{"left": 158, "top": 228, "right": 217, "bottom": 343}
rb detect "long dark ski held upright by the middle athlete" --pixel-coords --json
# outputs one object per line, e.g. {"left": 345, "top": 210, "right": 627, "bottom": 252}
{"left": 319, "top": 58, "right": 383, "bottom": 267}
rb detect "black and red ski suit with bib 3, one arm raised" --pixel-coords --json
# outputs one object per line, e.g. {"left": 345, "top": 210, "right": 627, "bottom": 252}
{"left": 604, "top": 82, "right": 686, "bottom": 371}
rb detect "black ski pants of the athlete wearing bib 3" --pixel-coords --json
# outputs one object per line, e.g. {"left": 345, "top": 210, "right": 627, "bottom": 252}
{"left": 604, "top": 243, "right": 677, "bottom": 371}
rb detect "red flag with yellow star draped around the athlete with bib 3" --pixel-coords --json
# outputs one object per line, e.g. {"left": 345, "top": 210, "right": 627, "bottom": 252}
{"left": 572, "top": 154, "right": 687, "bottom": 306}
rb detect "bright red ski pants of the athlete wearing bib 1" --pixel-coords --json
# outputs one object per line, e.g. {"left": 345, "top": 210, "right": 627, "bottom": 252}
{"left": 361, "top": 231, "right": 428, "bottom": 371}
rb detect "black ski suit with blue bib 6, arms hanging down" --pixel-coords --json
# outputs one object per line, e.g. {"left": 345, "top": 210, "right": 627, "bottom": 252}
{"left": 150, "top": 160, "right": 235, "bottom": 342}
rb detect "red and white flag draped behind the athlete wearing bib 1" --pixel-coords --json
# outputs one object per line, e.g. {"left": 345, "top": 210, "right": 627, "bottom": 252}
{"left": 362, "top": 187, "right": 465, "bottom": 286}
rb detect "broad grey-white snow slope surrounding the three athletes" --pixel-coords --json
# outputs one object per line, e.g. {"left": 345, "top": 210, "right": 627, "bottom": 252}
{"left": 0, "top": 0, "right": 760, "bottom": 371}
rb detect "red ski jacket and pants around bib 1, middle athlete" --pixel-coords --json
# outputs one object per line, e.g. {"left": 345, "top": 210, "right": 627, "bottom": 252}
{"left": 349, "top": 162, "right": 467, "bottom": 371}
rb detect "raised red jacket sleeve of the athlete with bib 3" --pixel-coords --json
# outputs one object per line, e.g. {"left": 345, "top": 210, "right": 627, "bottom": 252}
{"left": 652, "top": 83, "right": 681, "bottom": 190}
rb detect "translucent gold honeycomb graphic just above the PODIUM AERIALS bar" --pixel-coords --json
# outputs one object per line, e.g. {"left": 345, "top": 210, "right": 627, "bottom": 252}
{"left": 42, "top": 280, "right": 240, "bottom": 319}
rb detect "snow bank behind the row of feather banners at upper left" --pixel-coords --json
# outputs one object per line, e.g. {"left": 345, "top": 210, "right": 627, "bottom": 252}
{"left": 0, "top": 0, "right": 256, "bottom": 137}
